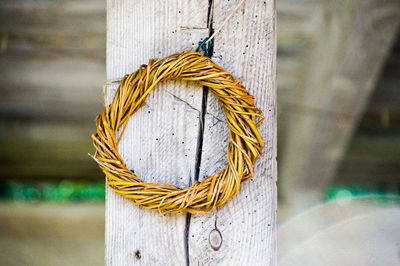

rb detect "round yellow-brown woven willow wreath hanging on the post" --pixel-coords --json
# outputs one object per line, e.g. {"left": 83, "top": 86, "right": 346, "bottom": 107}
{"left": 92, "top": 52, "right": 264, "bottom": 213}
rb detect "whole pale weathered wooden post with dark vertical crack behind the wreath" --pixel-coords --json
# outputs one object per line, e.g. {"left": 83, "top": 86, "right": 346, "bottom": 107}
{"left": 106, "top": 0, "right": 276, "bottom": 265}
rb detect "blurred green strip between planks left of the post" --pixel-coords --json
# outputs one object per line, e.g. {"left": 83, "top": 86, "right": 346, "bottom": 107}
{"left": 0, "top": 180, "right": 105, "bottom": 202}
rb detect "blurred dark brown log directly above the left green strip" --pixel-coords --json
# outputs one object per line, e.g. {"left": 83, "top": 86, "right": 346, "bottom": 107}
{"left": 0, "top": 121, "right": 102, "bottom": 180}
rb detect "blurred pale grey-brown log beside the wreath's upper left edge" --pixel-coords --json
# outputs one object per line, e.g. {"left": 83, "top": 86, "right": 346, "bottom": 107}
{"left": 0, "top": 52, "right": 105, "bottom": 123}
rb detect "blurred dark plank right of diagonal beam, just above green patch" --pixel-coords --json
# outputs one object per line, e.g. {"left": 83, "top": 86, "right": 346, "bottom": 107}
{"left": 335, "top": 129, "right": 400, "bottom": 185}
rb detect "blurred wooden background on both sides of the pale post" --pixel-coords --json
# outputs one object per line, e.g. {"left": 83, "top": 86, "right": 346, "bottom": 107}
{"left": 0, "top": 0, "right": 400, "bottom": 265}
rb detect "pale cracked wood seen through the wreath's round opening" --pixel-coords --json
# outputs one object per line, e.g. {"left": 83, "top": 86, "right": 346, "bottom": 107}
{"left": 117, "top": 80, "right": 228, "bottom": 188}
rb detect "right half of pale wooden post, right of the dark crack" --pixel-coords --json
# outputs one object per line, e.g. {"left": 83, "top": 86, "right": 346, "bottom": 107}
{"left": 188, "top": 0, "right": 277, "bottom": 265}
